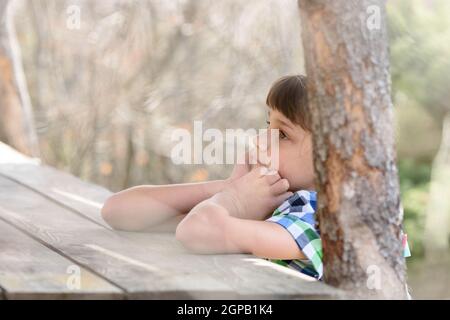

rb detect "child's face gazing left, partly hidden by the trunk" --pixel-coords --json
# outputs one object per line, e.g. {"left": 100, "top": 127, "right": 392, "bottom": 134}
{"left": 258, "top": 109, "right": 315, "bottom": 192}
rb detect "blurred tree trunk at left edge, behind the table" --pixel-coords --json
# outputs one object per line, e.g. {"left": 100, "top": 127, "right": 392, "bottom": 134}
{"left": 0, "top": 1, "right": 39, "bottom": 157}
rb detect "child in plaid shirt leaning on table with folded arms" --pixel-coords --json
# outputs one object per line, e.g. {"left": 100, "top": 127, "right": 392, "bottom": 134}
{"left": 102, "top": 75, "right": 410, "bottom": 279}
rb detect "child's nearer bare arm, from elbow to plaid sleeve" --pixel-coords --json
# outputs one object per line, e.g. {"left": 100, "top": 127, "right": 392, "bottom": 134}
{"left": 176, "top": 201, "right": 307, "bottom": 259}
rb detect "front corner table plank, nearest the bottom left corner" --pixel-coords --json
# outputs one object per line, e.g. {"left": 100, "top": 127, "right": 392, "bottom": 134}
{"left": 0, "top": 219, "right": 124, "bottom": 299}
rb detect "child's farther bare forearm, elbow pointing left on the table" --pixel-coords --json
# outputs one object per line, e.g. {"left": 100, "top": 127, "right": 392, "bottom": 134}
{"left": 102, "top": 180, "right": 227, "bottom": 231}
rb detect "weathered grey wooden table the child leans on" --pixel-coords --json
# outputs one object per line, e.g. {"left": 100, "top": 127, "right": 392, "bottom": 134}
{"left": 0, "top": 143, "right": 338, "bottom": 299}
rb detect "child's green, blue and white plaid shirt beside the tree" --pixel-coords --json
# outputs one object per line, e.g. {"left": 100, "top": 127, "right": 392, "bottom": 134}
{"left": 266, "top": 190, "right": 411, "bottom": 280}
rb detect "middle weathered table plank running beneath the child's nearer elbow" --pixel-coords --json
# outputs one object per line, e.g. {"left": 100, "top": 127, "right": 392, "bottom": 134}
{"left": 0, "top": 177, "right": 337, "bottom": 299}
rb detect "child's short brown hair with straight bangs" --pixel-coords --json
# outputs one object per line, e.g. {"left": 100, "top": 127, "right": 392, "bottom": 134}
{"left": 266, "top": 75, "right": 311, "bottom": 132}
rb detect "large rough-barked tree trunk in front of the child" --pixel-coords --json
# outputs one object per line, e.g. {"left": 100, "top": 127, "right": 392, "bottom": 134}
{"left": 299, "top": 0, "right": 406, "bottom": 299}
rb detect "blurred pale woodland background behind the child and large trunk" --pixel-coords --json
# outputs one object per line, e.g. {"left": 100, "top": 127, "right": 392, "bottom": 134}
{"left": 0, "top": 0, "right": 450, "bottom": 298}
